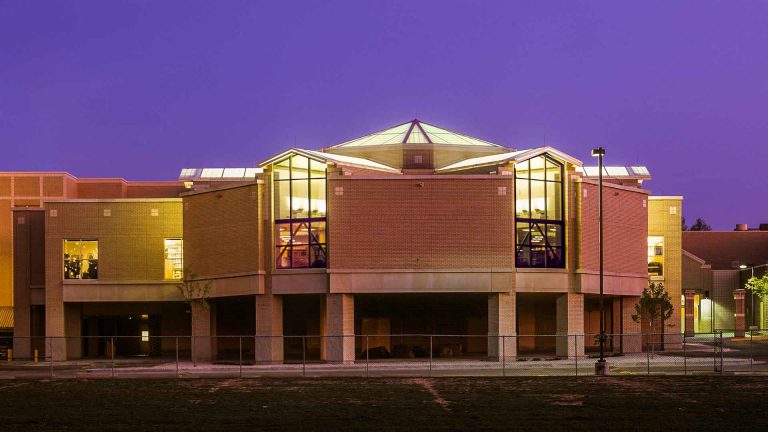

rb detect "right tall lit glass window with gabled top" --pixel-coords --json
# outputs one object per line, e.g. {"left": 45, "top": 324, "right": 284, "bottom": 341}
{"left": 515, "top": 155, "right": 565, "bottom": 268}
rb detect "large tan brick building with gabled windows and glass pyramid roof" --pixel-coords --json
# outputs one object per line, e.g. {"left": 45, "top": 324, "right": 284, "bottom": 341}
{"left": 6, "top": 120, "right": 682, "bottom": 362}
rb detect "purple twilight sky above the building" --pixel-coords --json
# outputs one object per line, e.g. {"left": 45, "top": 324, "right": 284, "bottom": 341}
{"left": 0, "top": 0, "right": 768, "bottom": 229}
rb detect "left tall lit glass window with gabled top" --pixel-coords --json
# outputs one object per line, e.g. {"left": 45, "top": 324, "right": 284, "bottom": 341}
{"left": 272, "top": 155, "right": 328, "bottom": 269}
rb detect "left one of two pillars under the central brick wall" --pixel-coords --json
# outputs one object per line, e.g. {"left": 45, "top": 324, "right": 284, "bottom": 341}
{"left": 323, "top": 294, "right": 355, "bottom": 364}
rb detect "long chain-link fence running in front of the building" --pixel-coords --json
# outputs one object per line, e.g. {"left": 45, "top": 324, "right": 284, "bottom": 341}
{"left": 0, "top": 330, "right": 768, "bottom": 378}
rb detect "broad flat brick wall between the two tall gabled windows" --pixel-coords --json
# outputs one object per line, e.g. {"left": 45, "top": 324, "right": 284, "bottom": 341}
{"left": 328, "top": 177, "right": 514, "bottom": 269}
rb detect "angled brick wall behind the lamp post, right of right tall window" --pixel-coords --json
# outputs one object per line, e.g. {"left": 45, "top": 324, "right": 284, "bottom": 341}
{"left": 576, "top": 182, "right": 648, "bottom": 274}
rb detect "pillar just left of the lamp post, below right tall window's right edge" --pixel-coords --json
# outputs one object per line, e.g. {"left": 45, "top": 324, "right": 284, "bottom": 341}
{"left": 556, "top": 293, "right": 584, "bottom": 357}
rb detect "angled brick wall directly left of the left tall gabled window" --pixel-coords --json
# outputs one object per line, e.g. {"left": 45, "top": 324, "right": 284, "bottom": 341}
{"left": 184, "top": 184, "right": 264, "bottom": 277}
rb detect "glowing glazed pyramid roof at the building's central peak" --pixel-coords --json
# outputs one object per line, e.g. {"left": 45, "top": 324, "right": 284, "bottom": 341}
{"left": 330, "top": 119, "right": 503, "bottom": 148}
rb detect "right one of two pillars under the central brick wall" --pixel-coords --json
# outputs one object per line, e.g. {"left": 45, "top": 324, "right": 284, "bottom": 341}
{"left": 488, "top": 292, "right": 517, "bottom": 361}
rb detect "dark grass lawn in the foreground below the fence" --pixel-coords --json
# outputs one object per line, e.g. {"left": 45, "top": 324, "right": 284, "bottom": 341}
{"left": 0, "top": 376, "right": 768, "bottom": 432}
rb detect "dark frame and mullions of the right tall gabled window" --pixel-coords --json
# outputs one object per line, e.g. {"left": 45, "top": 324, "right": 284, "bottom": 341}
{"left": 513, "top": 153, "right": 567, "bottom": 269}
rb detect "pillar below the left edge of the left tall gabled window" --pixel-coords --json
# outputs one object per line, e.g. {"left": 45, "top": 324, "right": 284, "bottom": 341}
{"left": 255, "top": 294, "right": 283, "bottom": 364}
